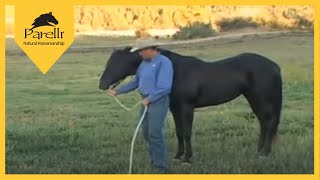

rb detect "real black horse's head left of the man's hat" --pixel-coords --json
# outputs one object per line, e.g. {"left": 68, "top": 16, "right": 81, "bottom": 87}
{"left": 99, "top": 47, "right": 142, "bottom": 90}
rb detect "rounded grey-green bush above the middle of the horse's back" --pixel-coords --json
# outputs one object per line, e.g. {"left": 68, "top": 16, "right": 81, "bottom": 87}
{"left": 173, "top": 22, "right": 216, "bottom": 39}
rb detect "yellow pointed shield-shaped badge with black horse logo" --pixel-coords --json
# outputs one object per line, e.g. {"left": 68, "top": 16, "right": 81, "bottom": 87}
{"left": 14, "top": 0, "right": 74, "bottom": 74}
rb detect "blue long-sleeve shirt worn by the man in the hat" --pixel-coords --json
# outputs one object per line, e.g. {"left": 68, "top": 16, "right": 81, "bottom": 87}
{"left": 116, "top": 53, "right": 173, "bottom": 103}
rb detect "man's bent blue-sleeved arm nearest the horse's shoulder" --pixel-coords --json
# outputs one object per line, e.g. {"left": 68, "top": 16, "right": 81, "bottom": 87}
{"left": 147, "top": 60, "right": 173, "bottom": 103}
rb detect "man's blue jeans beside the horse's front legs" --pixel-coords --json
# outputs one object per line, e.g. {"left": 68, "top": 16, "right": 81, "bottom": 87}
{"left": 140, "top": 95, "right": 169, "bottom": 169}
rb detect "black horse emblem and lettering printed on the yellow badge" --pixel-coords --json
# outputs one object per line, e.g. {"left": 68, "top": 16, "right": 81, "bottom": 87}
{"left": 23, "top": 12, "right": 64, "bottom": 46}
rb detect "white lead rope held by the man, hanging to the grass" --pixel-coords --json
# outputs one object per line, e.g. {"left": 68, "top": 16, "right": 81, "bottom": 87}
{"left": 113, "top": 96, "right": 148, "bottom": 174}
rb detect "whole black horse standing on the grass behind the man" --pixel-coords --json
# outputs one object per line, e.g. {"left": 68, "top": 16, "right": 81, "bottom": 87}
{"left": 99, "top": 47, "right": 282, "bottom": 163}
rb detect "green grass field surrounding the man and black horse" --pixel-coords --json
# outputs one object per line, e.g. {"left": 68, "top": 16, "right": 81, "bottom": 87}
{"left": 6, "top": 36, "right": 314, "bottom": 174}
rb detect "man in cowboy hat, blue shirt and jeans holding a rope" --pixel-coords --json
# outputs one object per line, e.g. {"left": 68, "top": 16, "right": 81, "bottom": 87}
{"left": 107, "top": 39, "right": 173, "bottom": 172}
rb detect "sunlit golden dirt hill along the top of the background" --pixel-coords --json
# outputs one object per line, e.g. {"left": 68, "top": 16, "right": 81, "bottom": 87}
{"left": 6, "top": 6, "right": 314, "bottom": 34}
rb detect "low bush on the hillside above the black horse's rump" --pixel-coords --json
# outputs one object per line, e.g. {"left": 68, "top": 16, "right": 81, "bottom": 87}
{"left": 217, "top": 17, "right": 258, "bottom": 31}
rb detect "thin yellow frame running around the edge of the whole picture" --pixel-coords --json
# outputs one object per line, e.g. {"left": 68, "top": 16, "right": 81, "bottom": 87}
{"left": 0, "top": 0, "right": 320, "bottom": 180}
